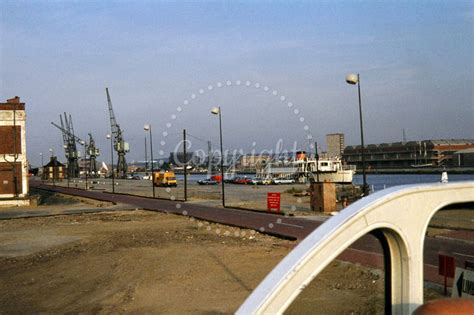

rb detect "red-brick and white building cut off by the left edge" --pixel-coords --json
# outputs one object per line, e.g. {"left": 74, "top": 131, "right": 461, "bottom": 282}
{"left": 0, "top": 96, "right": 29, "bottom": 205}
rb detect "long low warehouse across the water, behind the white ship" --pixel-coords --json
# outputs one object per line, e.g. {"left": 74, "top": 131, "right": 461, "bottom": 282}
{"left": 343, "top": 139, "right": 474, "bottom": 169}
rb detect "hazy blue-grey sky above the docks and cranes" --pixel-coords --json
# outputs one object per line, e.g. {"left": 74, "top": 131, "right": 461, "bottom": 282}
{"left": 0, "top": 0, "right": 474, "bottom": 168}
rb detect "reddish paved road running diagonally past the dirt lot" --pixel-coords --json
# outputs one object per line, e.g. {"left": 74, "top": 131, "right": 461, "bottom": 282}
{"left": 30, "top": 181, "right": 474, "bottom": 284}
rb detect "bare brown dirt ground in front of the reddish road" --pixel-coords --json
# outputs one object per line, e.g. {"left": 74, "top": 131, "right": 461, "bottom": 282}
{"left": 0, "top": 207, "right": 394, "bottom": 314}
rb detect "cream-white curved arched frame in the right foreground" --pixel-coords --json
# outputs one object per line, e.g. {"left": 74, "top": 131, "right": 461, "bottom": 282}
{"left": 237, "top": 181, "right": 474, "bottom": 314}
